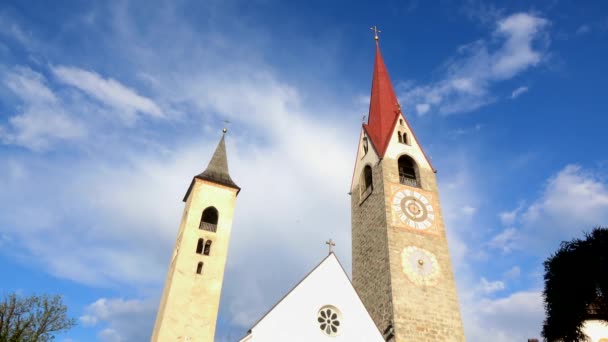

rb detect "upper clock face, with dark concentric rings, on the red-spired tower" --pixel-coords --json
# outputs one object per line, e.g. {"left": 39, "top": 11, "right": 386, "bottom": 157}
{"left": 392, "top": 189, "right": 435, "bottom": 230}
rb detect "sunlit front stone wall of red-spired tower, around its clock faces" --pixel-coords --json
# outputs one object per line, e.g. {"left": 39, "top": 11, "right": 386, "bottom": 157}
{"left": 382, "top": 158, "right": 465, "bottom": 342}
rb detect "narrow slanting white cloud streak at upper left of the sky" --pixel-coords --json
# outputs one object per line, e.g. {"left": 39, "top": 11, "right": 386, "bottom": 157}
{"left": 52, "top": 66, "right": 164, "bottom": 123}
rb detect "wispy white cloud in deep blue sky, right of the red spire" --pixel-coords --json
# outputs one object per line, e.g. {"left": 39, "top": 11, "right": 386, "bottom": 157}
{"left": 400, "top": 13, "right": 549, "bottom": 115}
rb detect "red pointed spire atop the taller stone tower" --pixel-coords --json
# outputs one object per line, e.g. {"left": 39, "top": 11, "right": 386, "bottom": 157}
{"left": 364, "top": 40, "right": 401, "bottom": 157}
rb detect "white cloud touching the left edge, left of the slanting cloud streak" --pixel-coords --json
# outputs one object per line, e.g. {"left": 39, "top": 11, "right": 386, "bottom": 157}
{"left": 0, "top": 67, "right": 87, "bottom": 150}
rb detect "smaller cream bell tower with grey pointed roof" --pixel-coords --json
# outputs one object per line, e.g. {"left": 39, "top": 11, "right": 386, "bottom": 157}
{"left": 152, "top": 129, "right": 240, "bottom": 342}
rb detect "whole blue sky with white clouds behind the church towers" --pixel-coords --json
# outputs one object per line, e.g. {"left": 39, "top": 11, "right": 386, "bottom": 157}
{"left": 0, "top": 0, "right": 608, "bottom": 341}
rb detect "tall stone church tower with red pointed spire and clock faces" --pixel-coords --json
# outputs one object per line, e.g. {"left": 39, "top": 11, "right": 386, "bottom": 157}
{"left": 351, "top": 35, "right": 465, "bottom": 342}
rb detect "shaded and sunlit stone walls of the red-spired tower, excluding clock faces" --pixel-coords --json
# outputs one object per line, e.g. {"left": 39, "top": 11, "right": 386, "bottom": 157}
{"left": 351, "top": 158, "right": 465, "bottom": 342}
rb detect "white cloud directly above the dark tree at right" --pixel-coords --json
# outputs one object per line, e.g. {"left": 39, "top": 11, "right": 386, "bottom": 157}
{"left": 488, "top": 164, "right": 608, "bottom": 256}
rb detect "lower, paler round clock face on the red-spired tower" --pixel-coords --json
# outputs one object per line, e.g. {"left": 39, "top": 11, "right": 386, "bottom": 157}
{"left": 401, "top": 246, "right": 441, "bottom": 286}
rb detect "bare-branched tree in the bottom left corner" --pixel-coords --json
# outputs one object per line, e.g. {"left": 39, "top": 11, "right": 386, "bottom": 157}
{"left": 0, "top": 293, "right": 76, "bottom": 342}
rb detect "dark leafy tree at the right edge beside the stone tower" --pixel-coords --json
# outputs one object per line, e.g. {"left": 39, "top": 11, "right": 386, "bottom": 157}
{"left": 542, "top": 227, "right": 608, "bottom": 342}
